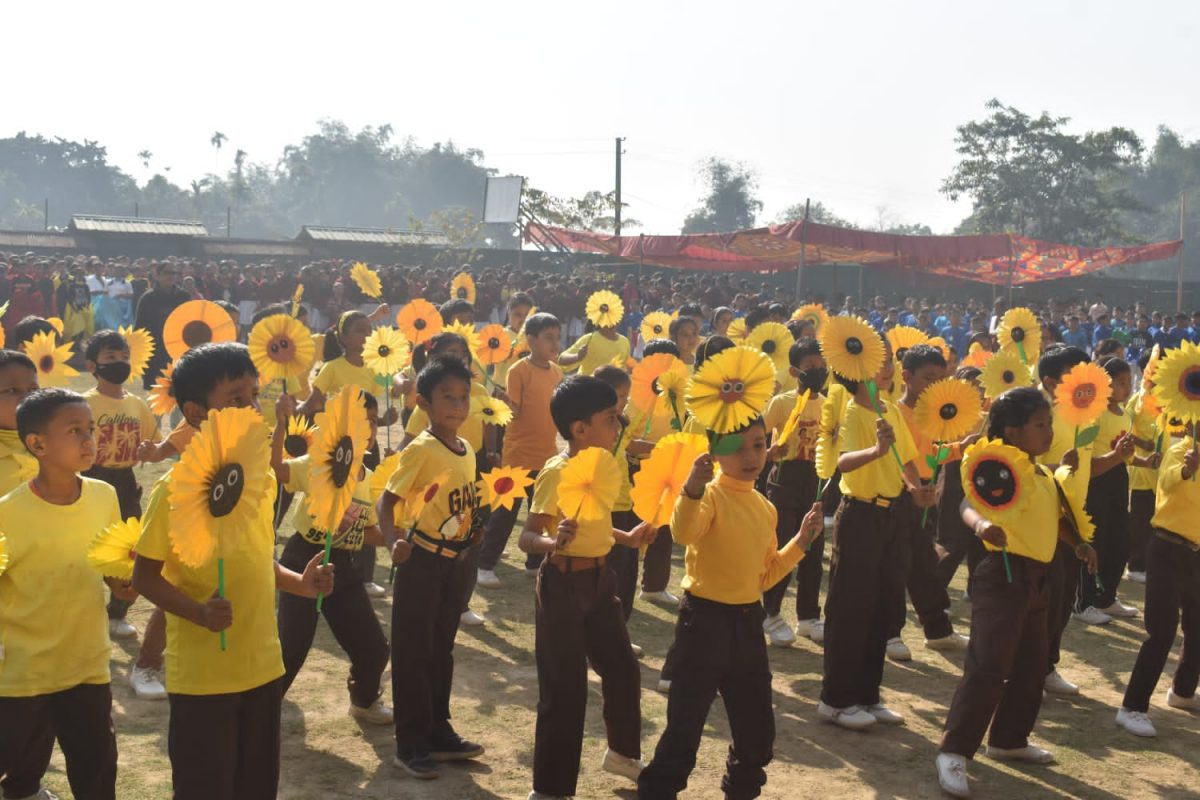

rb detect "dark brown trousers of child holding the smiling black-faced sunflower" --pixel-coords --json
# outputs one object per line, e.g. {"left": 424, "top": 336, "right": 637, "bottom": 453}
{"left": 941, "top": 553, "right": 1051, "bottom": 758}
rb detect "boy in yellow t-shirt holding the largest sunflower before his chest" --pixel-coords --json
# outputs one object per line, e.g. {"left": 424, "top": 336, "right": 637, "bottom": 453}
{"left": 133, "top": 342, "right": 334, "bottom": 800}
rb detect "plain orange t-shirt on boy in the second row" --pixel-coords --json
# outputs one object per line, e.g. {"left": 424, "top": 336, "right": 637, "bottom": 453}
{"left": 504, "top": 359, "right": 563, "bottom": 469}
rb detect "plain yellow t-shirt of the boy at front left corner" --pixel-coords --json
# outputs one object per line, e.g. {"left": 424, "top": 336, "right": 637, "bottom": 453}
{"left": 0, "top": 477, "right": 121, "bottom": 697}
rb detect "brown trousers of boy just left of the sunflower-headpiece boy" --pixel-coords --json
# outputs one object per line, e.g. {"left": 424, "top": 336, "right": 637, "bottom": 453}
{"left": 533, "top": 560, "right": 643, "bottom": 796}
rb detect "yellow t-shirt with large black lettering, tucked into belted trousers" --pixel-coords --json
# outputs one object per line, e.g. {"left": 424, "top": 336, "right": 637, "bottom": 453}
{"left": 388, "top": 431, "right": 479, "bottom": 540}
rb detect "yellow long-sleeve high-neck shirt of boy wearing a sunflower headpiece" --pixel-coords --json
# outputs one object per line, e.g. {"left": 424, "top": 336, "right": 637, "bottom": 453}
{"left": 671, "top": 474, "right": 804, "bottom": 604}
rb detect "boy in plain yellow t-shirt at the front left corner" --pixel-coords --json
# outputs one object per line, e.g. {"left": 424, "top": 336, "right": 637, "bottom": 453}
{"left": 0, "top": 388, "right": 125, "bottom": 800}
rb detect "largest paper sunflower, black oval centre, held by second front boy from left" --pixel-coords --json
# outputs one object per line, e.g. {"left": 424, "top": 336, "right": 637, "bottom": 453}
{"left": 169, "top": 407, "right": 275, "bottom": 569}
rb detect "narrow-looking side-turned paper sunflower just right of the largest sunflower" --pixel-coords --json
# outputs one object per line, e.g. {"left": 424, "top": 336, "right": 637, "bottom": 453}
{"left": 308, "top": 386, "right": 371, "bottom": 533}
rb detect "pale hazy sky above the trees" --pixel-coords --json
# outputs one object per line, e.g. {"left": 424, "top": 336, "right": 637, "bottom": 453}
{"left": 9, "top": 0, "right": 1200, "bottom": 234}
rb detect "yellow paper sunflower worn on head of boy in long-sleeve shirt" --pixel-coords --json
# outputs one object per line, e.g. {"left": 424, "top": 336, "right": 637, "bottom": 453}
{"left": 685, "top": 347, "right": 775, "bottom": 435}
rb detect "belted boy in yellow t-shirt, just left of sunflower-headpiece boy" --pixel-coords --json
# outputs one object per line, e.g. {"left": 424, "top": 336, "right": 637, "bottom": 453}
{"left": 520, "top": 375, "right": 652, "bottom": 799}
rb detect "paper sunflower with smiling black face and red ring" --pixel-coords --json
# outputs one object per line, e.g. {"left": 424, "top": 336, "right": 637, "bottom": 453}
{"left": 961, "top": 439, "right": 1033, "bottom": 530}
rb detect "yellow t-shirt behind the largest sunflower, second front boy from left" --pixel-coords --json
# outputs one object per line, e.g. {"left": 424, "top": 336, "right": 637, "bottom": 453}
{"left": 137, "top": 468, "right": 283, "bottom": 694}
